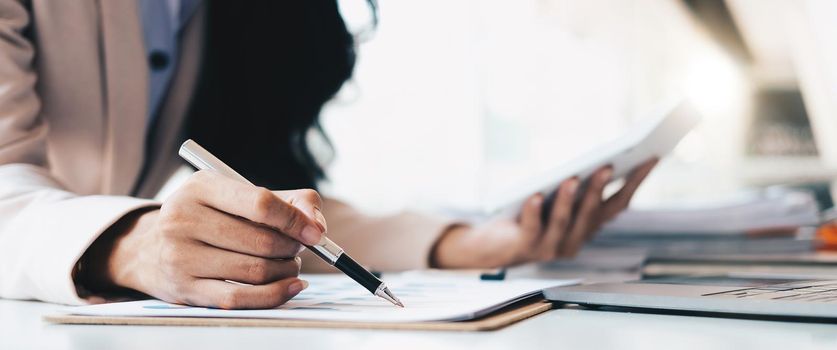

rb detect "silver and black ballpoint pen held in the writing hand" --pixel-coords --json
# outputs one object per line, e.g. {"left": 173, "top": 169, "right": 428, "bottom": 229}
{"left": 178, "top": 140, "right": 404, "bottom": 307}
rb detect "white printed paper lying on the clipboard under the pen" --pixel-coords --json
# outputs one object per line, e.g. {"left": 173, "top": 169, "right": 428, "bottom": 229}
{"left": 66, "top": 275, "right": 577, "bottom": 322}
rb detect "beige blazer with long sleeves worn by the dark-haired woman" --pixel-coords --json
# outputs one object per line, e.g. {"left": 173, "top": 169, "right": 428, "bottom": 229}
{"left": 0, "top": 0, "right": 447, "bottom": 304}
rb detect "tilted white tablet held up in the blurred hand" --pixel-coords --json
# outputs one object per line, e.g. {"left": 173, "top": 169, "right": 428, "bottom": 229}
{"left": 482, "top": 100, "right": 700, "bottom": 216}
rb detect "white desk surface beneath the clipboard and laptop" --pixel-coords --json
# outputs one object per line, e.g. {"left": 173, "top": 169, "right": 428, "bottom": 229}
{"left": 0, "top": 264, "right": 837, "bottom": 350}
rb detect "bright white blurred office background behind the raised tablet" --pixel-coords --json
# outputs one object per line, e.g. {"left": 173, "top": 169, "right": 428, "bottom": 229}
{"left": 311, "top": 0, "right": 837, "bottom": 214}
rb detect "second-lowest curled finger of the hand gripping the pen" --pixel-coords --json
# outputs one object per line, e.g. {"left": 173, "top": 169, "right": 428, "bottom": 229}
{"left": 185, "top": 246, "right": 301, "bottom": 284}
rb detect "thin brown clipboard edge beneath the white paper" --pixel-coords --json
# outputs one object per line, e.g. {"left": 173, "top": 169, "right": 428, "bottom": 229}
{"left": 43, "top": 295, "right": 553, "bottom": 332}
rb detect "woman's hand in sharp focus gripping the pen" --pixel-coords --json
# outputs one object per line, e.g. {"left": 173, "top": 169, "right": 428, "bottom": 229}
{"left": 81, "top": 171, "right": 326, "bottom": 309}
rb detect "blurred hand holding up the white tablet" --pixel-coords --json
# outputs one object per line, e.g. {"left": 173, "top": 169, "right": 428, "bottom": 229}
{"left": 431, "top": 160, "right": 657, "bottom": 268}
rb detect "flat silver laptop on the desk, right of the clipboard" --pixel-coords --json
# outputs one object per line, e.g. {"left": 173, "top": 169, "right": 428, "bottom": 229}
{"left": 544, "top": 276, "right": 837, "bottom": 319}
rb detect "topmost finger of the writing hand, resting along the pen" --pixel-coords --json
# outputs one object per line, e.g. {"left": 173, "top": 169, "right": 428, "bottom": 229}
{"left": 185, "top": 170, "right": 325, "bottom": 245}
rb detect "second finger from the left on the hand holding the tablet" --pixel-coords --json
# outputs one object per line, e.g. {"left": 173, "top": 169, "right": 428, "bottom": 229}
{"left": 538, "top": 178, "right": 578, "bottom": 261}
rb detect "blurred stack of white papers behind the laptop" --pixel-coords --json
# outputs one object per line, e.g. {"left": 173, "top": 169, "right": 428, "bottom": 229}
{"left": 592, "top": 188, "right": 820, "bottom": 255}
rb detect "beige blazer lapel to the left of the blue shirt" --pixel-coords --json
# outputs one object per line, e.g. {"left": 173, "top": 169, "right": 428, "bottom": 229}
{"left": 99, "top": 0, "right": 148, "bottom": 194}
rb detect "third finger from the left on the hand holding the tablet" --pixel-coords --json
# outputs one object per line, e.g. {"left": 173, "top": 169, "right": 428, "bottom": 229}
{"left": 559, "top": 167, "right": 613, "bottom": 256}
